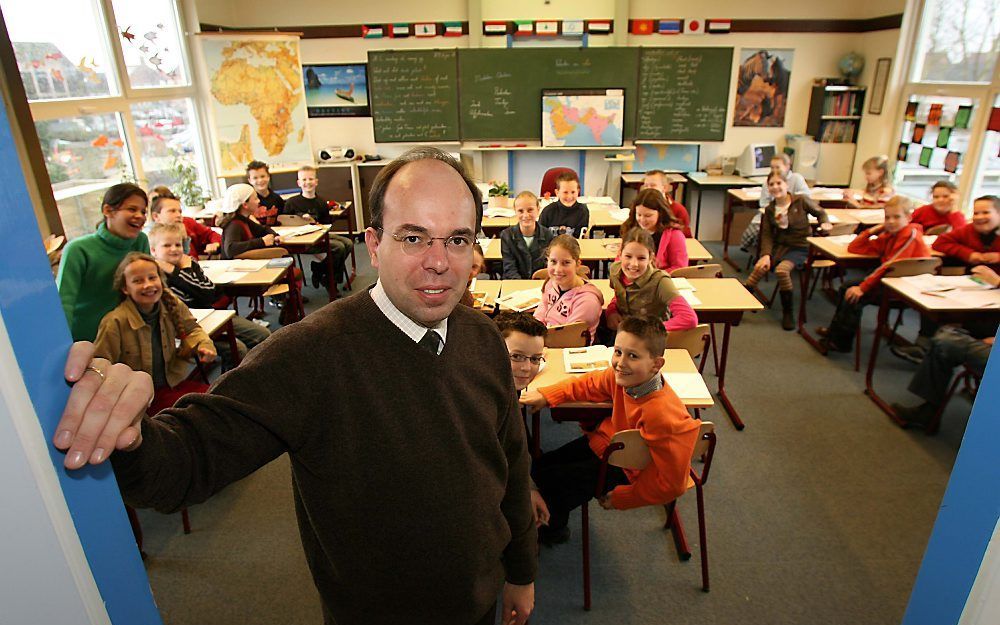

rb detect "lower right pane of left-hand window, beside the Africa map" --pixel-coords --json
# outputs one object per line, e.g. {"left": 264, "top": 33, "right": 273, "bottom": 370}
{"left": 132, "top": 99, "right": 204, "bottom": 189}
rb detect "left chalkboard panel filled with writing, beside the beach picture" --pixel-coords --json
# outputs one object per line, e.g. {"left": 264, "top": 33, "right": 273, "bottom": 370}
{"left": 368, "top": 50, "right": 459, "bottom": 143}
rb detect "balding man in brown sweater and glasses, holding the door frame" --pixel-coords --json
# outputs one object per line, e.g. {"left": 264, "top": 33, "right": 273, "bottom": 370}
{"left": 55, "top": 148, "right": 536, "bottom": 625}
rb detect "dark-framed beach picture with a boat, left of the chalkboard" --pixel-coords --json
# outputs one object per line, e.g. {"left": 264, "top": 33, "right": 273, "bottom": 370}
{"left": 302, "top": 63, "right": 372, "bottom": 117}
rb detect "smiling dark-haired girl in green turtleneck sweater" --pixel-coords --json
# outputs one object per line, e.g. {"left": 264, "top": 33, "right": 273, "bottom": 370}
{"left": 56, "top": 183, "right": 149, "bottom": 341}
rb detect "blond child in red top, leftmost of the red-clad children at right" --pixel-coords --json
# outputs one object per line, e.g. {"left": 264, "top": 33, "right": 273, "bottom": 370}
{"left": 817, "top": 196, "right": 931, "bottom": 353}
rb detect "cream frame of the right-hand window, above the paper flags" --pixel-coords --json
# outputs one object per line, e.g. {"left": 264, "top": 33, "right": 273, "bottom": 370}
{"left": 888, "top": 0, "right": 1000, "bottom": 215}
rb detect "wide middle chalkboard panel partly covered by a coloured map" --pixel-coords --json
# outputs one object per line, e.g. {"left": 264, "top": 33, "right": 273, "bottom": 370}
{"left": 458, "top": 48, "right": 639, "bottom": 141}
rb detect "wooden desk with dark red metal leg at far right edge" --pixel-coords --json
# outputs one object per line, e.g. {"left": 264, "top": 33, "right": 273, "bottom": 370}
{"left": 865, "top": 276, "right": 1000, "bottom": 425}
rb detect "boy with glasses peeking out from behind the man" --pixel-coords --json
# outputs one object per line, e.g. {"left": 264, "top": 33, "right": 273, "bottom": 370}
{"left": 494, "top": 311, "right": 549, "bottom": 527}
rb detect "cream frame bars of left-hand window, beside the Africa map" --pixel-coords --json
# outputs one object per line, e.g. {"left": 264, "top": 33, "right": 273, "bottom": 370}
{"left": 22, "top": 0, "right": 211, "bottom": 205}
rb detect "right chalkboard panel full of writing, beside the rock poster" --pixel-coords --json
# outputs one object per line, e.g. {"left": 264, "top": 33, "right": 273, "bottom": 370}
{"left": 635, "top": 48, "right": 733, "bottom": 141}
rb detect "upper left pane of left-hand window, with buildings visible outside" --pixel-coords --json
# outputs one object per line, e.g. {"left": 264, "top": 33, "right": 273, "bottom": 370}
{"left": 0, "top": 0, "right": 118, "bottom": 100}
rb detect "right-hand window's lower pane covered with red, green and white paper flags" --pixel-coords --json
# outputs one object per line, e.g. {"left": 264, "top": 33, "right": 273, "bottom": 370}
{"left": 895, "top": 95, "right": 977, "bottom": 198}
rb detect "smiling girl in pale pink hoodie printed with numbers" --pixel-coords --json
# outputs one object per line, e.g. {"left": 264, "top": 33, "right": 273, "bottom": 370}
{"left": 535, "top": 234, "right": 604, "bottom": 343}
